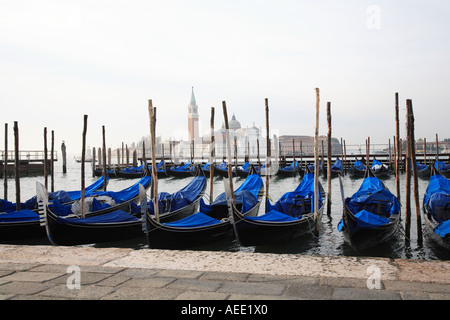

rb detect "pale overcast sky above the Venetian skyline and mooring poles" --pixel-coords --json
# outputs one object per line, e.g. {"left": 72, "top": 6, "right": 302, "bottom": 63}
{"left": 0, "top": 0, "right": 450, "bottom": 154}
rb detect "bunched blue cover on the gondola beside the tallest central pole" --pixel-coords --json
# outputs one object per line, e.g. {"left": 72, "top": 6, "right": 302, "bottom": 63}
{"left": 267, "top": 173, "right": 323, "bottom": 217}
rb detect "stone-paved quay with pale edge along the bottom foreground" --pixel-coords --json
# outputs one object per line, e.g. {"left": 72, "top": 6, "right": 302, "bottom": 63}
{"left": 0, "top": 245, "right": 450, "bottom": 304}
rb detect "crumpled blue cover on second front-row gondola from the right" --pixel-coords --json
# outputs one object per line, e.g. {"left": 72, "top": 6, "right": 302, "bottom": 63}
{"left": 345, "top": 177, "right": 400, "bottom": 217}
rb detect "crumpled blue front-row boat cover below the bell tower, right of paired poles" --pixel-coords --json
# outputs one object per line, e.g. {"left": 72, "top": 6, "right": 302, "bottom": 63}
{"left": 148, "top": 176, "right": 206, "bottom": 212}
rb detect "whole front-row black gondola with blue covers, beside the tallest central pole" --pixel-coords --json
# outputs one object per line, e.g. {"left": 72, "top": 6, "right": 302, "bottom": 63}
{"left": 233, "top": 169, "right": 325, "bottom": 246}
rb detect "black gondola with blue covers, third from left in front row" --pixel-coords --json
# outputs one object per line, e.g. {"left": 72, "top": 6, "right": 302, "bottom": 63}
{"left": 146, "top": 165, "right": 263, "bottom": 249}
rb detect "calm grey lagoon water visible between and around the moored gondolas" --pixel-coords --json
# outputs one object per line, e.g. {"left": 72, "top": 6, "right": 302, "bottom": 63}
{"left": 0, "top": 158, "right": 450, "bottom": 260}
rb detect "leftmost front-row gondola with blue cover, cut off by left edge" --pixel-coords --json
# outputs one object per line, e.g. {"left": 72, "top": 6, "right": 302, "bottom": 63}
{"left": 0, "top": 177, "right": 108, "bottom": 240}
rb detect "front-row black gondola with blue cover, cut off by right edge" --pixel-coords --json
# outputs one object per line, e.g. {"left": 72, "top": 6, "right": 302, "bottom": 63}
{"left": 422, "top": 168, "right": 450, "bottom": 250}
